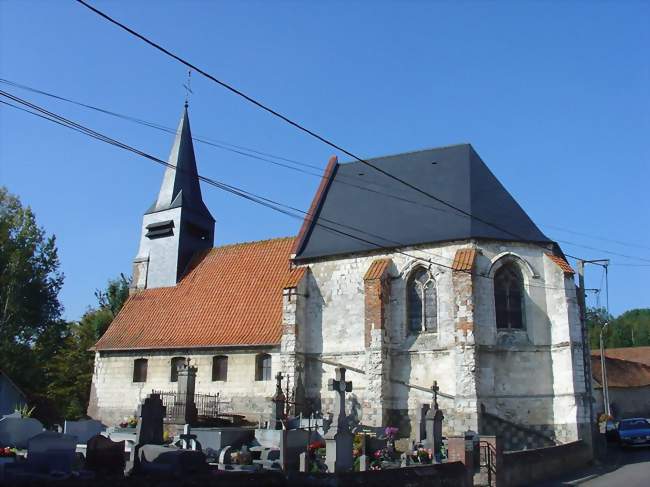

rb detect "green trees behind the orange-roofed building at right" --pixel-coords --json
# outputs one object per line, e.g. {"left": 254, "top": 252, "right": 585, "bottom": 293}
{"left": 586, "top": 308, "right": 650, "bottom": 350}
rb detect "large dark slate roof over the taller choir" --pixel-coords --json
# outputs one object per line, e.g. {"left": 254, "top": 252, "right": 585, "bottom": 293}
{"left": 294, "top": 144, "right": 551, "bottom": 260}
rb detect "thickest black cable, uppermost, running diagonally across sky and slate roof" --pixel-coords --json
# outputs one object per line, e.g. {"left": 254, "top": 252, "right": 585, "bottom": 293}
{"left": 76, "top": 0, "right": 596, "bottom": 259}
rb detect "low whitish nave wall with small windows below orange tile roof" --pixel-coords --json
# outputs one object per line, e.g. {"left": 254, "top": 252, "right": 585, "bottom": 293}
{"left": 88, "top": 349, "right": 280, "bottom": 425}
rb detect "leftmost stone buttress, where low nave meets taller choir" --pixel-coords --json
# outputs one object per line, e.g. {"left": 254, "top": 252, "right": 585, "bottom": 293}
{"left": 280, "top": 267, "right": 309, "bottom": 414}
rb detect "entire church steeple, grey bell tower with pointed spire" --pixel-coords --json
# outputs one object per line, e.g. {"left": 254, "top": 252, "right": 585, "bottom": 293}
{"left": 132, "top": 102, "right": 214, "bottom": 289}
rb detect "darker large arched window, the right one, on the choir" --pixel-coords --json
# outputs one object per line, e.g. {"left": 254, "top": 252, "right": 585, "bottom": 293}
{"left": 494, "top": 263, "right": 524, "bottom": 329}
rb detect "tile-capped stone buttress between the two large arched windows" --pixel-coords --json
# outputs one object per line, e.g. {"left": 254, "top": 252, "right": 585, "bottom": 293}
{"left": 449, "top": 249, "right": 479, "bottom": 435}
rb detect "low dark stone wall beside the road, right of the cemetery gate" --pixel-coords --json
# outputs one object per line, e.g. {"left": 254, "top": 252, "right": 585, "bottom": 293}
{"left": 497, "top": 441, "right": 592, "bottom": 487}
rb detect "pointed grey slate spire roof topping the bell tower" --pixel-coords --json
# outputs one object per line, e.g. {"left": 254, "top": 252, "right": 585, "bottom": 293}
{"left": 147, "top": 105, "right": 214, "bottom": 220}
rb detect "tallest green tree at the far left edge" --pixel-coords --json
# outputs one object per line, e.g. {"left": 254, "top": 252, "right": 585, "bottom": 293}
{"left": 0, "top": 187, "right": 67, "bottom": 394}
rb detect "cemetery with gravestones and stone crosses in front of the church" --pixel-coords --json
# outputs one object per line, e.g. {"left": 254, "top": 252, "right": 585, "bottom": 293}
{"left": 0, "top": 363, "right": 471, "bottom": 486}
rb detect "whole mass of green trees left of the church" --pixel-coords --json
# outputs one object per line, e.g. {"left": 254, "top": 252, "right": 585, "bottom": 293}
{"left": 0, "top": 187, "right": 129, "bottom": 424}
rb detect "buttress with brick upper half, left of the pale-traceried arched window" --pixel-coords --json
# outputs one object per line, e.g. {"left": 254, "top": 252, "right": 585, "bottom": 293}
{"left": 363, "top": 259, "right": 392, "bottom": 427}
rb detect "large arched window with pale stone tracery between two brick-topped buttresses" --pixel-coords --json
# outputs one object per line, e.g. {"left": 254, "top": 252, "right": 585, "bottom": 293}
{"left": 406, "top": 267, "right": 438, "bottom": 333}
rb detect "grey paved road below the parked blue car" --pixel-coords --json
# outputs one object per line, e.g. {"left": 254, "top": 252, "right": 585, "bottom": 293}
{"left": 536, "top": 444, "right": 650, "bottom": 487}
